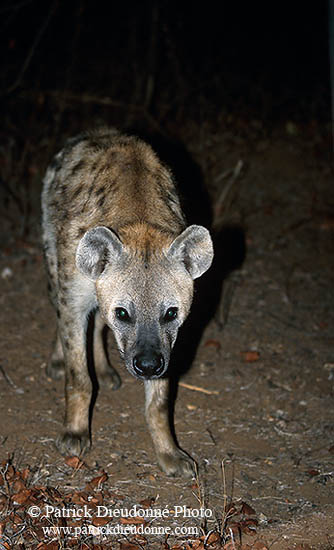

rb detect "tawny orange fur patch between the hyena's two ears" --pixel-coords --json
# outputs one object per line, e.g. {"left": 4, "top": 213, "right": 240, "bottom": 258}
{"left": 118, "top": 222, "right": 177, "bottom": 259}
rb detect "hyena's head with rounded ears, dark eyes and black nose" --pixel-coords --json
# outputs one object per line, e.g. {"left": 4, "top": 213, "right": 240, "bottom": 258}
{"left": 76, "top": 225, "right": 213, "bottom": 379}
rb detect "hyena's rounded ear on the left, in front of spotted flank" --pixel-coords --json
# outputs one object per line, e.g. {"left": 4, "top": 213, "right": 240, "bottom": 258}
{"left": 76, "top": 226, "right": 123, "bottom": 281}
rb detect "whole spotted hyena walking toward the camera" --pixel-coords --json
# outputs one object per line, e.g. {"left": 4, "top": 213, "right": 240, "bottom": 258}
{"left": 42, "top": 128, "right": 213, "bottom": 476}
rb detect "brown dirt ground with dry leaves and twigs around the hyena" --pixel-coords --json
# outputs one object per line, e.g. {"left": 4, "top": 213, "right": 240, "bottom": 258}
{"left": 0, "top": 123, "right": 334, "bottom": 550}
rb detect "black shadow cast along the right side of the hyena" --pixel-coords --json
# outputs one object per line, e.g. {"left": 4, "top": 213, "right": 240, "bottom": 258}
{"left": 134, "top": 135, "right": 246, "bottom": 435}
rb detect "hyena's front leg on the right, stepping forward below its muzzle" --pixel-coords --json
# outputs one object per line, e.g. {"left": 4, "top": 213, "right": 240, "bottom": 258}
{"left": 145, "top": 378, "right": 195, "bottom": 477}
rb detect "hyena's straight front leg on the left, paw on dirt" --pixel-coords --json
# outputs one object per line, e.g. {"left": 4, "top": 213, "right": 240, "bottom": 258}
{"left": 56, "top": 299, "right": 92, "bottom": 456}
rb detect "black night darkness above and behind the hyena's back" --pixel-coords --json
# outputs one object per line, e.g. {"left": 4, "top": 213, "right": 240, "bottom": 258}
{"left": 0, "top": 0, "right": 331, "bottom": 242}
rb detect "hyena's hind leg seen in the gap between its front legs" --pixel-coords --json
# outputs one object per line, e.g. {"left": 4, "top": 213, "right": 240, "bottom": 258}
{"left": 93, "top": 311, "right": 121, "bottom": 390}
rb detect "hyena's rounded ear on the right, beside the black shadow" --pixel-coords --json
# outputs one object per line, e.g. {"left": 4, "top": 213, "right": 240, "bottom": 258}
{"left": 168, "top": 225, "right": 213, "bottom": 279}
